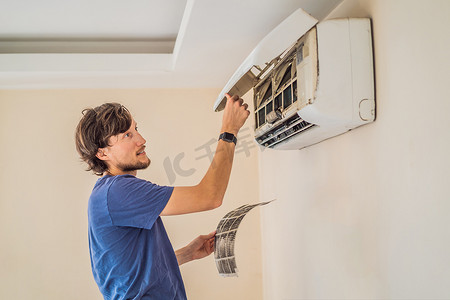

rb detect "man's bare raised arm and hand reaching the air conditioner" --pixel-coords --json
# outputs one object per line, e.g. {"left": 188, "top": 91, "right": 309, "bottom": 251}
{"left": 161, "top": 94, "right": 250, "bottom": 216}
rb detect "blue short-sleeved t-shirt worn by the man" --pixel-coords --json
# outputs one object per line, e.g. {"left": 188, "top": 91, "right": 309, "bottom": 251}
{"left": 88, "top": 175, "right": 186, "bottom": 300}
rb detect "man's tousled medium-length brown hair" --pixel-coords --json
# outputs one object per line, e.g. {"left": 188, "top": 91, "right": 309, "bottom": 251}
{"left": 75, "top": 103, "right": 132, "bottom": 176}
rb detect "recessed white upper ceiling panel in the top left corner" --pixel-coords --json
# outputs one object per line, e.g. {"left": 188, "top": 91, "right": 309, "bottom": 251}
{"left": 0, "top": 0, "right": 186, "bottom": 39}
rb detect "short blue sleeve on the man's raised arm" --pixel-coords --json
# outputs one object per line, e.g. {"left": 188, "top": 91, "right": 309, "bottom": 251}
{"left": 107, "top": 175, "right": 173, "bottom": 229}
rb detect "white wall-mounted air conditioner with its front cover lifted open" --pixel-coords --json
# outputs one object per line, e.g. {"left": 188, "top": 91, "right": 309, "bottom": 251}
{"left": 214, "top": 9, "right": 375, "bottom": 149}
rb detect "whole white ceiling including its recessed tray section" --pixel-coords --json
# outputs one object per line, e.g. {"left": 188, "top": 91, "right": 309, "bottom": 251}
{"left": 0, "top": 0, "right": 342, "bottom": 89}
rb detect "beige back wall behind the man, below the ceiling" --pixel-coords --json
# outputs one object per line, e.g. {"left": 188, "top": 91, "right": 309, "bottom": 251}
{"left": 0, "top": 89, "right": 262, "bottom": 300}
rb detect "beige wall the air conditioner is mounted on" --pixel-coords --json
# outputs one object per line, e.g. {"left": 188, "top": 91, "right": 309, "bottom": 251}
{"left": 260, "top": 0, "right": 450, "bottom": 300}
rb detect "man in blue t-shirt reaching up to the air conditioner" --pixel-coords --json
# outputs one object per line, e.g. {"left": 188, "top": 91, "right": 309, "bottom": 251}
{"left": 75, "top": 94, "right": 249, "bottom": 300}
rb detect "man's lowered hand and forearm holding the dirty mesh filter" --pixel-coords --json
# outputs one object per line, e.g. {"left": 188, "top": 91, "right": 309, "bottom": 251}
{"left": 175, "top": 231, "right": 216, "bottom": 266}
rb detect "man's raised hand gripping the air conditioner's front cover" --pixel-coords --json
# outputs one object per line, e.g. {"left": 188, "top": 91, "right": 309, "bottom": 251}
{"left": 221, "top": 94, "right": 250, "bottom": 136}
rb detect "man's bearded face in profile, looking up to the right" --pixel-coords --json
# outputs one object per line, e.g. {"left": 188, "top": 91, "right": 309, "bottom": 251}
{"left": 99, "top": 120, "right": 150, "bottom": 175}
